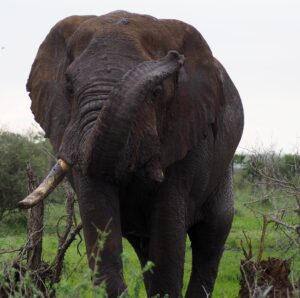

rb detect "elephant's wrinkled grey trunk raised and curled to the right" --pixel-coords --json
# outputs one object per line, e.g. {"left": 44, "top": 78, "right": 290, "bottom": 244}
{"left": 81, "top": 51, "right": 184, "bottom": 179}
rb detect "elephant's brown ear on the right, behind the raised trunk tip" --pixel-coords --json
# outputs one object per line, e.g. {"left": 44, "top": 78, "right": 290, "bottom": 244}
{"left": 160, "top": 20, "right": 223, "bottom": 168}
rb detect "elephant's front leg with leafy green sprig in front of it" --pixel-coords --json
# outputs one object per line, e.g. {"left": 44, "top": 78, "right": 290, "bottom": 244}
{"left": 77, "top": 173, "right": 126, "bottom": 297}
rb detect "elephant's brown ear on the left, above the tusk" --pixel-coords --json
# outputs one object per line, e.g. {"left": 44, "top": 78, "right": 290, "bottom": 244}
{"left": 26, "top": 16, "right": 93, "bottom": 152}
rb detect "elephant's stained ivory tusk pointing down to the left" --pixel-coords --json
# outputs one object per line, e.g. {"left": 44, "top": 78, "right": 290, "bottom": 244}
{"left": 18, "top": 159, "right": 71, "bottom": 209}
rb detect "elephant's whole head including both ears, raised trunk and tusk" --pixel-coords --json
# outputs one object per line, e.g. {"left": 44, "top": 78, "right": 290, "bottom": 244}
{"left": 20, "top": 11, "right": 222, "bottom": 207}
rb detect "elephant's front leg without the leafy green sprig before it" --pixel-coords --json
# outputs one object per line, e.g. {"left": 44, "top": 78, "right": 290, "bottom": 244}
{"left": 148, "top": 183, "right": 186, "bottom": 298}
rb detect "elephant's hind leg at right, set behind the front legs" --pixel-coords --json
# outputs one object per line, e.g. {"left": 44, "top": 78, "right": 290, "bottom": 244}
{"left": 186, "top": 171, "right": 233, "bottom": 298}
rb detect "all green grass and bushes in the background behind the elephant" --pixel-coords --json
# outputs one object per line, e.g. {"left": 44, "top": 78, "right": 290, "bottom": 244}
{"left": 0, "top": 131, "right": 300, "bottom": 298}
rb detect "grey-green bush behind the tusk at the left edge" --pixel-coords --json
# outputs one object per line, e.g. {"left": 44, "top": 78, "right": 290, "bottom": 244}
{"left": 0, "top": 131, "right": 53, "bottom": 219}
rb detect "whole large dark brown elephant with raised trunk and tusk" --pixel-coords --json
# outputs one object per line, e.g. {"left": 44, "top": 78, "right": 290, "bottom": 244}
{"left": 19, "top": 11, "right": 244, "bottom": 297}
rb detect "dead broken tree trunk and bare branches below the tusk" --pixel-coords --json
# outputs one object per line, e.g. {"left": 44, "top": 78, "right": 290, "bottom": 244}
{"left": 0, "top": 165, "right": 82, "bottom": 297}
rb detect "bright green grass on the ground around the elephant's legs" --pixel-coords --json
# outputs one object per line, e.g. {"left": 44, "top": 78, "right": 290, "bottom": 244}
{"left": 0, "top": 180, "right": 300, "bottom": 298}
